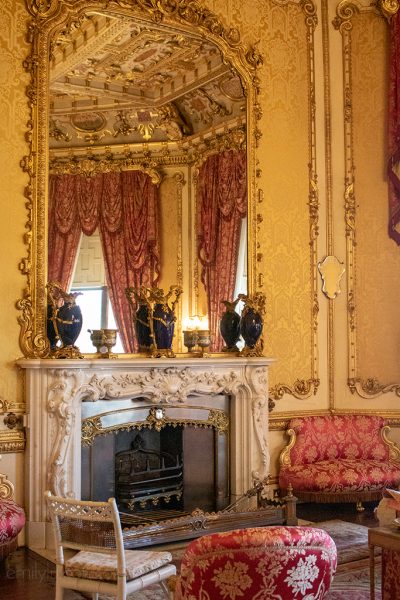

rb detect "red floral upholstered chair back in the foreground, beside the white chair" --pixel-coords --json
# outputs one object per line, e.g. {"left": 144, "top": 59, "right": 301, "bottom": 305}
{"left": 175, "top": 526, "right": 337, "bottom": 600}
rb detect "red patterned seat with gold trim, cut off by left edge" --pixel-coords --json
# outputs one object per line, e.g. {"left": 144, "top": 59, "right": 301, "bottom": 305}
{"left": 0, "top": 473, "right": 25, "bottom": 560}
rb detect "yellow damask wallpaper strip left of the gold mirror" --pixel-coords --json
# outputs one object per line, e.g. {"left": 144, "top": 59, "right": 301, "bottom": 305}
{"left": 0, "top": 0, "right": 29, "bottom": 408}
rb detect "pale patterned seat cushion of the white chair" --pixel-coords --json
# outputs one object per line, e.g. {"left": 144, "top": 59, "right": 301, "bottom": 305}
{"left": 65, "top": 550, "right": 172, "bottom": 581}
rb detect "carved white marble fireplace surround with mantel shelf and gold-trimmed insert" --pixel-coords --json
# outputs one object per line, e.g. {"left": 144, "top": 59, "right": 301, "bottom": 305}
{"left": 18, "top": 356, "right": 272, "bottom": 548}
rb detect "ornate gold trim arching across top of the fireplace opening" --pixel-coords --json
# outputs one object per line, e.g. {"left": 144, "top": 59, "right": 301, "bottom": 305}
{"left": 82, "top": 404, "right": 229, "bottom": 446}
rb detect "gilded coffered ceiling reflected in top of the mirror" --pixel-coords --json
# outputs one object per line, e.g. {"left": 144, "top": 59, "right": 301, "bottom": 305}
{"left": 50, "top": 13, "right": 246, "bottom": 151}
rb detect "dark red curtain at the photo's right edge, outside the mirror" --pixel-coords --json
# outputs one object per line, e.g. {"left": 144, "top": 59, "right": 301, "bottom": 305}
{"left": 388, "top": 12, "right": 400, "bottom": 244}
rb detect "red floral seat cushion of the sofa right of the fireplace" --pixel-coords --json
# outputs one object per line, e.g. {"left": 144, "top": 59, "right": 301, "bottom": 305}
{"left": 279, "top": 460, "right": 400, "bottom": 493}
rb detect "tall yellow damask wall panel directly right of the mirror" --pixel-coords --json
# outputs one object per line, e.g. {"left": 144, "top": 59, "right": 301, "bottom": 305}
{"left": 260, "top": 2, "right": 318, "bottom": 398}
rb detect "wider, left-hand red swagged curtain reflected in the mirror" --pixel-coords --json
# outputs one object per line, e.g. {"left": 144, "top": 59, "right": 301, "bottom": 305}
{"left": 48, "top": 171, "right": 160, "bottom": 352}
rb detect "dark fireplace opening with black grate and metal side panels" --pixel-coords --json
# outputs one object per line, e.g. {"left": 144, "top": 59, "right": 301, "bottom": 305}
{"left": 81, "top": 418, "right": 230, "bottom": 524}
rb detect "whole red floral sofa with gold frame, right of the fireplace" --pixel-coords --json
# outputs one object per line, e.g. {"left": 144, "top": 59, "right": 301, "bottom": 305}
{"left": 279, "top": 415, "right": 400, "bottom": 510}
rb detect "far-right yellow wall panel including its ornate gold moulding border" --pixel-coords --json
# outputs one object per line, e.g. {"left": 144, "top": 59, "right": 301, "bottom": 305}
{"left": 335, "top": 2, "right": 400, "bottom": 398}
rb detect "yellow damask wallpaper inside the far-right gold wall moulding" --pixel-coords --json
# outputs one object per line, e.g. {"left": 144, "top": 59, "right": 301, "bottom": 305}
{"left": 352, "top": 13, "right": 400, "bottom": 384}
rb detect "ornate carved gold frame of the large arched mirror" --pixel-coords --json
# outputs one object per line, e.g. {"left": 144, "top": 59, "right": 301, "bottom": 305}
{"left": 17, "top": 0, "right": 262, "bottom": 358}
